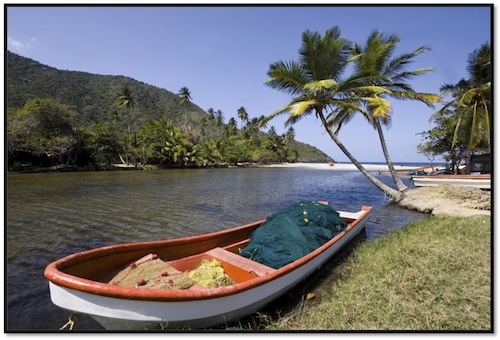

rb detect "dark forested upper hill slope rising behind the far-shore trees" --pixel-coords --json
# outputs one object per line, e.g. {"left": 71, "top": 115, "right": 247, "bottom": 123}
{"left": 6, "top": 52, "right": 330, "bottom": 166}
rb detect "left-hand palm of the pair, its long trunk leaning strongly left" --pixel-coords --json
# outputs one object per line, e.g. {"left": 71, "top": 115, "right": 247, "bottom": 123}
{"left": 264, "top": 27, "right": 403, "bottom": 201}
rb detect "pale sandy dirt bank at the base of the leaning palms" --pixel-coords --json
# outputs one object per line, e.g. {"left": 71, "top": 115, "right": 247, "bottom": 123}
{"left": 398, "top": 185, "right": 491, "bottom": 217}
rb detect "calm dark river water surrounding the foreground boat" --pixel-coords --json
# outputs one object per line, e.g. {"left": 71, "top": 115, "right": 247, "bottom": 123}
{"left": 5, "top": 168, "right": 425, "bottom": 331}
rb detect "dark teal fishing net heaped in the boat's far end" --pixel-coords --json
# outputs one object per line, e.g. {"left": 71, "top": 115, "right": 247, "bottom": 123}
{"left": 240, "top": 201, "right": 347, "bottom": 269}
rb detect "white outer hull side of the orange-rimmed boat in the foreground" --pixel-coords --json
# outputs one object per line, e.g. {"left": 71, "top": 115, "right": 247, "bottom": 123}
{"left": 49, "top": 212, "right": 368, "bottom": 330}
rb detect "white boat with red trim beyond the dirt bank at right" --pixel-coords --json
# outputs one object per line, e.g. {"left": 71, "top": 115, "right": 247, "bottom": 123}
{"left": 411, "top": 174, "right": 491, "bottom": 190}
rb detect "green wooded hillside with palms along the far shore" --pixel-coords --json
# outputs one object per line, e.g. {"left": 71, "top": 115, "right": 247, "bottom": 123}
{"left": 7, "top": 52, "right": 330, "bottom": 170}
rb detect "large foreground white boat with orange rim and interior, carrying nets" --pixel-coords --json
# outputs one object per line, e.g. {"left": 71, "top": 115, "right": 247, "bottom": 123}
{"left": 44, "top": 201, "right": 372, "bottom": 330}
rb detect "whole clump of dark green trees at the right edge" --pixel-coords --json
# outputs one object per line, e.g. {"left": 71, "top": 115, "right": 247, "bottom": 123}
{"left": 418, "top": 43, "right": 493, "bottom": 172}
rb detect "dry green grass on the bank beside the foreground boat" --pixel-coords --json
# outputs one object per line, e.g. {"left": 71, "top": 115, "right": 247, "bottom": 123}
{"left": 266, "top": 217, "right": 493, "bottom": 332}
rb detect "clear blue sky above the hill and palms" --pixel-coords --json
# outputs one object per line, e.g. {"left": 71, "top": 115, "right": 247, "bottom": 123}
{"left": 6, "top": 4, "right": 492, "bottom": 163}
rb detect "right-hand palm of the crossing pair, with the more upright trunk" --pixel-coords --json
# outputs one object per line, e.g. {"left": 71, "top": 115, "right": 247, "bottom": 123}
{"left": 334, "top": 31, "right": 439, "bottom": 191}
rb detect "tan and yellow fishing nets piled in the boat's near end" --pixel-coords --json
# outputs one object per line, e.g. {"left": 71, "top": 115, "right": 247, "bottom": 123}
{"left": 109, "top": 254, "right": 234, "bottom": 289}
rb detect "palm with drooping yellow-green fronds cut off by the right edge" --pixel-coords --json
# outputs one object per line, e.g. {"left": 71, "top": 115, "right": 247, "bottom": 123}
{"left": 430, "top": 43, "right": 492, "bottom": 151}
